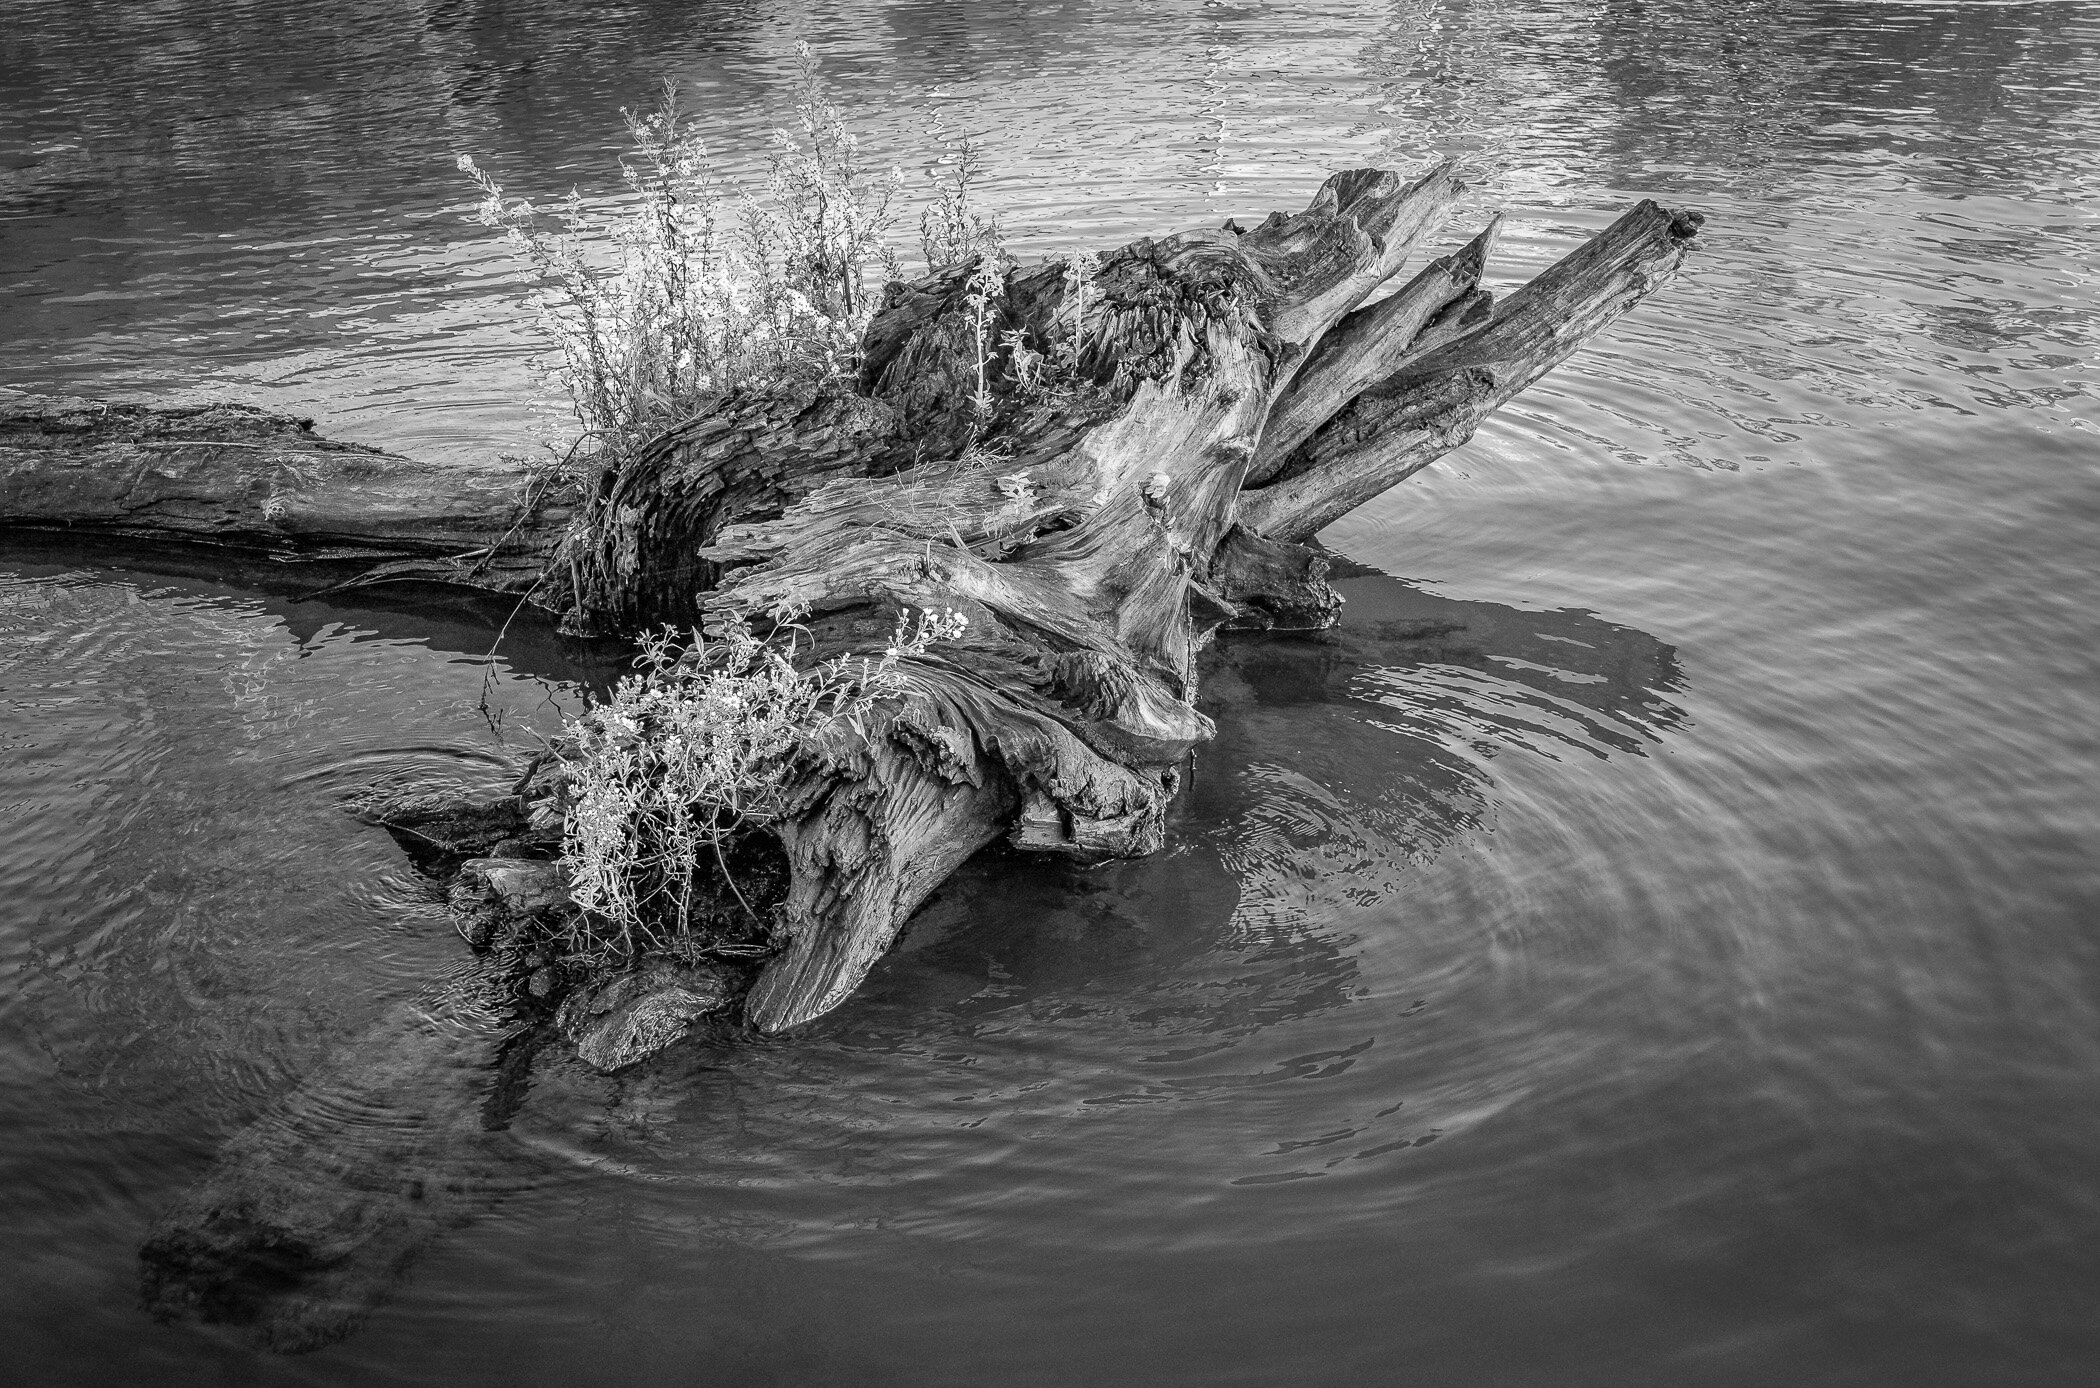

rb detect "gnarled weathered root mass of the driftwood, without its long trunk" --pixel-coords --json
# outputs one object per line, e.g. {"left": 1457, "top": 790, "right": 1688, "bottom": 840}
{"left": 586, "top": 181, "right": 1699, "bottom": 1031}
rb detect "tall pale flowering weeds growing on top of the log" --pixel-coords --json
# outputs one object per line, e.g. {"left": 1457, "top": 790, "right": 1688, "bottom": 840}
{"left": 458, "top": 44, "right": 901, "bottom": 466}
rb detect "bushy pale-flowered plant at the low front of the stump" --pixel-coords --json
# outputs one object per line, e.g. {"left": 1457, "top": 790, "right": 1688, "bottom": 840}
{"left": 563, "top": 611, "right": 968, "bottom": 964}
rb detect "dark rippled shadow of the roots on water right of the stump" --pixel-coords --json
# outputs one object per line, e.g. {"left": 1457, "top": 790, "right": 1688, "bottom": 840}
{"left": 818, "top": 545, "right": 1684, "bottom": 1042}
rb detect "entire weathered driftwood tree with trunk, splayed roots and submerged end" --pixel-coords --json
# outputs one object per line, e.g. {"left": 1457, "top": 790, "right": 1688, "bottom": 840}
{"left": 0, "top": 166, "right": 1701, "bottom": 1342}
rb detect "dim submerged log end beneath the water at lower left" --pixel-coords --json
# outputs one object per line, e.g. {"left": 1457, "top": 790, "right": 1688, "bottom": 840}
{"left": 141, "top": 978, "right": 537, "bottom": 1350}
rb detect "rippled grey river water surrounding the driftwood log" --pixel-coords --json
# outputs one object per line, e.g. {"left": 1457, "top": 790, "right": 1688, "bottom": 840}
{"left": 0, "top": 0, "right": 2100, "bottom": 1386}
